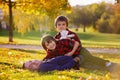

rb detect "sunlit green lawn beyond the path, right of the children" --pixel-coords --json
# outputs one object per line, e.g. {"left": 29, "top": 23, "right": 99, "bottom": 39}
{"left": 73, "top": 30, "right": 120, "bottom": 48}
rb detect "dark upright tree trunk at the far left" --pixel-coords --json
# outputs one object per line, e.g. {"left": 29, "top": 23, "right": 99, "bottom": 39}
{"left": 8, "top": 0, "right": 13, "bottom": 42}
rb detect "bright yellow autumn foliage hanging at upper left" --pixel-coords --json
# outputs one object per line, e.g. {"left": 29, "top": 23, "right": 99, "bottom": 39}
{"left": 2, "top": 0, "right": 71, "bottom": 34}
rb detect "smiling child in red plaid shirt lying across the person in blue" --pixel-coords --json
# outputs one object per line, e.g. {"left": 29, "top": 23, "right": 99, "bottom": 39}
{"left": 41, "top": 35, "right": 80, "bottom": 60}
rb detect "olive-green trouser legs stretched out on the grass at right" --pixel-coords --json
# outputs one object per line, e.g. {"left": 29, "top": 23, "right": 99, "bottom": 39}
{"left": 80, "top": 48, "right": 109, "bottom": 68}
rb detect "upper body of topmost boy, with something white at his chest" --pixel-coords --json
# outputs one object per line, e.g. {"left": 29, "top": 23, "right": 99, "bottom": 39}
{"left": 55, "top": 16, "right": 82, "bottom": 48}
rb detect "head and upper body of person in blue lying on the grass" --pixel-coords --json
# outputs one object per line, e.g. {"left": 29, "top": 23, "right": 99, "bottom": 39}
{"left": 23, "top": 56, "right": 79, "bottom": 72}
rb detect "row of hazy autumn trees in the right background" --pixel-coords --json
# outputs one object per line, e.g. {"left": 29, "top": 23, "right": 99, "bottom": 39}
{"left": 67, "top": 2, "right": 120, "bottom": 34}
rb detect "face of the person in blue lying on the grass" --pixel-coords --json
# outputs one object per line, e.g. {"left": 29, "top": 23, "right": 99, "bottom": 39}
{"left": 25, "top": 60, "right": 42, "bottom": 71}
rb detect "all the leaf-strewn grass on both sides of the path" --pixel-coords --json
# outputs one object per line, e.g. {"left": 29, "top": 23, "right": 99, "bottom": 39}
{"left": 0, "top": 30, "right": 120, "bottom": 80}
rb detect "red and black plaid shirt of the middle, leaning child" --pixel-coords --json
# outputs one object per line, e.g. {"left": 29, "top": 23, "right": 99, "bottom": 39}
{"left": 44, "top": 39, "right": 81, "bottom": 60}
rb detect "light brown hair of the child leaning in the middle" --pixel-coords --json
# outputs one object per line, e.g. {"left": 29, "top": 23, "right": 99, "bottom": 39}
{"left": 41, "top": 35, "right": 56, "bottom": 51}
